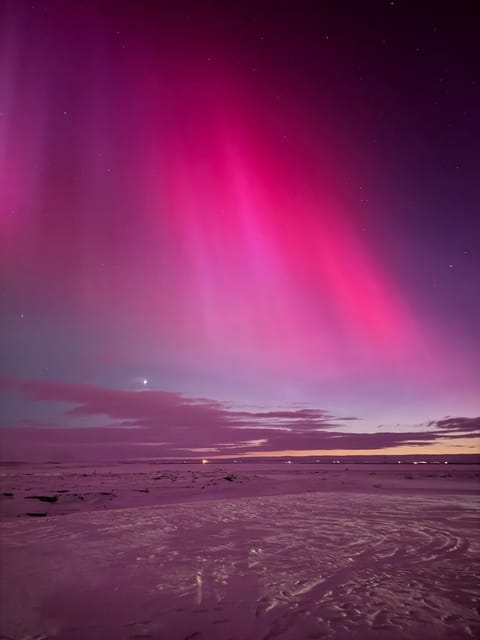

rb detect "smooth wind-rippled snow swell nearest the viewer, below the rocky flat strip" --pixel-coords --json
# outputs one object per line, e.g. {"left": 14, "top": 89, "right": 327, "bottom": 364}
{"left": 1, "top": 493, "right": 480, "bottom": 640}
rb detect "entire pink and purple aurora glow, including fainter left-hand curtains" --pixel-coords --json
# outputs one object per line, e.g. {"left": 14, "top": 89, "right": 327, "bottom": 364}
{"left": 0, "top": 4, "right": 478, "bottom": 438}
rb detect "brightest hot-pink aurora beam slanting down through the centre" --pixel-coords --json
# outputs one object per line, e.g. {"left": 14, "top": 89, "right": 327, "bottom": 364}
{"left": 134, "top": 63, "right": 433, "bottom": 384}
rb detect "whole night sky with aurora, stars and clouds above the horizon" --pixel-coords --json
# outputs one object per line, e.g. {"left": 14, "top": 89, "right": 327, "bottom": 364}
{"left": 0, "top": 0, "right": 480, "bottom": 460}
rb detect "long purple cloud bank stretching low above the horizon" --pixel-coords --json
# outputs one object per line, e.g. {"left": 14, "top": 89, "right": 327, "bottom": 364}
{"left": 0, "top": 378, "right": 480, "bottom": 458}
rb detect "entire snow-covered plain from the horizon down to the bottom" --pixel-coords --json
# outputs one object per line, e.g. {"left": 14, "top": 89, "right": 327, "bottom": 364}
{"left": 0, "top": 464, "right": 480, "bottom": 640}
